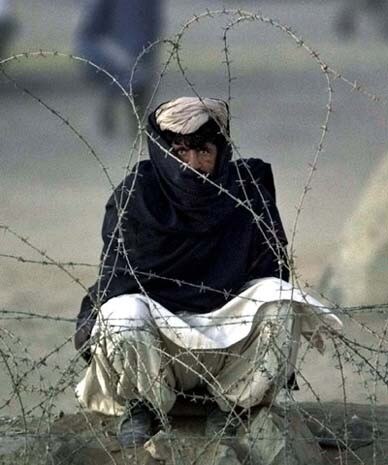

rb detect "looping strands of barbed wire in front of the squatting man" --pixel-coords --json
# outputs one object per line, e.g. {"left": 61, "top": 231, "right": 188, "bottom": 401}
{"left": 0, "top": 9, "right": 388, "bottom": 463}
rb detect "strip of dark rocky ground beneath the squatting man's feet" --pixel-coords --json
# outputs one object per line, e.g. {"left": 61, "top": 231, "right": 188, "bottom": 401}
{"left": 0, "top": 403, "right": 388, "bottom": 465}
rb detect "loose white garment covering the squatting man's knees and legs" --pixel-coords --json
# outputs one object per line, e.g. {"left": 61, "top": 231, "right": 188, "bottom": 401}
{"left": 76, "top": 278, "right": 342, "bottom": 415}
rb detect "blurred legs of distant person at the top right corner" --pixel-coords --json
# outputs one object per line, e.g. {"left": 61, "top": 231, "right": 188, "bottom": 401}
{"left": 335, "top": 0, "right": 388, "bottom": 39}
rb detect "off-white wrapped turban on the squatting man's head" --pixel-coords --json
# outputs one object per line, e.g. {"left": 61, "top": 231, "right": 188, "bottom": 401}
{"left": 155, "top": 97, "right": 228, "bottom": 134}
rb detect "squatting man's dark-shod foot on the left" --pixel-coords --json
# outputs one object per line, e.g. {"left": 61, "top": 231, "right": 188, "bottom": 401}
{"left": 117, "top": 400, "right": 153, "bottom": 447}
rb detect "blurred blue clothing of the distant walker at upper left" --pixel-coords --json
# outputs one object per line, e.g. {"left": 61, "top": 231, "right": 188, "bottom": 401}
{"left": 76, "top": 0, "right": 162, "bottom": 91}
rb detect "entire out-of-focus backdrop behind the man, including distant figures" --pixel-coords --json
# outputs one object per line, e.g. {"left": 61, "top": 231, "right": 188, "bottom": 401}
{"left": 0, "top": 0, "right": 388, "bottom": 415}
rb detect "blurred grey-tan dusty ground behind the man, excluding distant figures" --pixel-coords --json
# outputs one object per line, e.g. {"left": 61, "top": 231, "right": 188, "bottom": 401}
{"left": 0, "top": 0, "right": 388, "bottom": 415}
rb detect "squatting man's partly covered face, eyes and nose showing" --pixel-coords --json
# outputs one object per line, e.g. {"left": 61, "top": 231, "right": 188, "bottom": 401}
{"left": 172, "top": 142, "right": 217, "bottom": 174}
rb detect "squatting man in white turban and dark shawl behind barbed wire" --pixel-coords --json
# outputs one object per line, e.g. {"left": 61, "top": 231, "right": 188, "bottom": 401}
{"left": 75, "top": 97, "right": 341, "bottom": 446}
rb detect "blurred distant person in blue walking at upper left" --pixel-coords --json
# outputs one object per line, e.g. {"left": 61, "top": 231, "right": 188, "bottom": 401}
{"left": 76, "top": 0, "right": 162, "bottom": 135}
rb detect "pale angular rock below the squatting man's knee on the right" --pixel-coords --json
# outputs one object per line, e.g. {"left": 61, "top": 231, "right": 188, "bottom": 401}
{"left": 236, "top": 407, "right": 323, "bottom": 465}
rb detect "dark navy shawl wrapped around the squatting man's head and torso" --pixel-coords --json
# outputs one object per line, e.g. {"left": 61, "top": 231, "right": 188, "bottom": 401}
{"left": 76, "top": 116, "right": 288, "bottom": 348}
